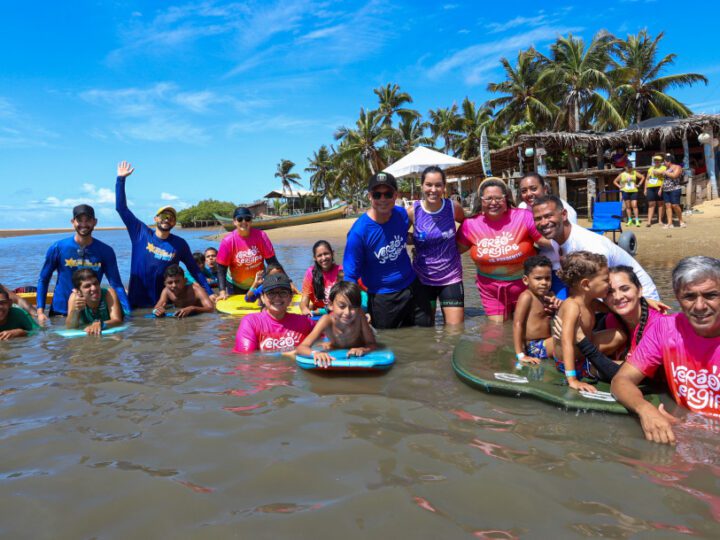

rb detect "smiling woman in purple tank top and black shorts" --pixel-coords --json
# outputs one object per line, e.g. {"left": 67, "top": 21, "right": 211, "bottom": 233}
{"left": 408, "top": 166, "right": 465, "bottom": 326}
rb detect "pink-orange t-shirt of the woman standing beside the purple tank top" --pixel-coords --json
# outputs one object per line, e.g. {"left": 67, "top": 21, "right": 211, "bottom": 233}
{"left": 455, "top": 208, "right": 542, "bottom": 281}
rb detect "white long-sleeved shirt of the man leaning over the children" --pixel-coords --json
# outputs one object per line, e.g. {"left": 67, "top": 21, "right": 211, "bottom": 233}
{"left": 543, "top": 224, "right": 660, "bottom": 300}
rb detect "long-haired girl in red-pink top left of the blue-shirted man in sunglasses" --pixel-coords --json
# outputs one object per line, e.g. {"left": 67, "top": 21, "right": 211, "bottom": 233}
{"left": 300, "top": 240, "right": 342, "bottom": 315}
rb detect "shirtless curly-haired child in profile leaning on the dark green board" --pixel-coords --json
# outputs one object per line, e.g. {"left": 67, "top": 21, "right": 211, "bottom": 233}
{"left": 555, "top": 251, "right": 610, "bottom": 392}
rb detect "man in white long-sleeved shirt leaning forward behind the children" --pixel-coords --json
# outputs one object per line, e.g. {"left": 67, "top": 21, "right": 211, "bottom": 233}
{"left": 533, "top": 195, "right": 660, "bottom": 300}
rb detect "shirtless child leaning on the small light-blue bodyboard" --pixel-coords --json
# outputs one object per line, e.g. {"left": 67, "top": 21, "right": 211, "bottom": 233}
{"left": 297, "top": 281, "right": 377, "bottom": 368}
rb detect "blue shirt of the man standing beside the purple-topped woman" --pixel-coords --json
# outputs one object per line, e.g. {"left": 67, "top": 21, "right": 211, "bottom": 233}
{"left": 343, "top": 206, "right": 415, "bottom": 294}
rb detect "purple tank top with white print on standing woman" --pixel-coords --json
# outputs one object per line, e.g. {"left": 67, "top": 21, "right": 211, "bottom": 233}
{"left": 413, "top": 199, "right": 462, "bottom": 287}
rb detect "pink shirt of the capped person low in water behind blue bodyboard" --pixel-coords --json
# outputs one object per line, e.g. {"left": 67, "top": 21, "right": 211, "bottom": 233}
{"left": 233, "top": 311, "right": 313, "bottom": 353}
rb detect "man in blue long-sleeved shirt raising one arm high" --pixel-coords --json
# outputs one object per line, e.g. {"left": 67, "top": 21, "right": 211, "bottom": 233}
{"left": 115, "top": 161, "right": 215, "bottom": 309}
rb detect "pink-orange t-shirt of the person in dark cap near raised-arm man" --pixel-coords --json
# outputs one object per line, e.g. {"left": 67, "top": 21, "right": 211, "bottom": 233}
{"left": 217, "top": 229, "right": 275, "bottom": 289}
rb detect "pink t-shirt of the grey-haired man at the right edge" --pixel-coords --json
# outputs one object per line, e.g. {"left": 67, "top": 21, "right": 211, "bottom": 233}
{"left": 629, "top": 313, "right": 720, "bottom": 416}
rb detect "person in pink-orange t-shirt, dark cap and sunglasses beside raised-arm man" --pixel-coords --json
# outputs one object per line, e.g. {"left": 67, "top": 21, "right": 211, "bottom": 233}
{"left": 217, "top": 206, "right": 280, "bottom": 300}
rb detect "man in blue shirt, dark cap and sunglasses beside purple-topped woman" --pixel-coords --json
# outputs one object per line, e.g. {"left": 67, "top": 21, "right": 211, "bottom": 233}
{"left": 343, "top": 173, "right": 417, "bottom": 328}
